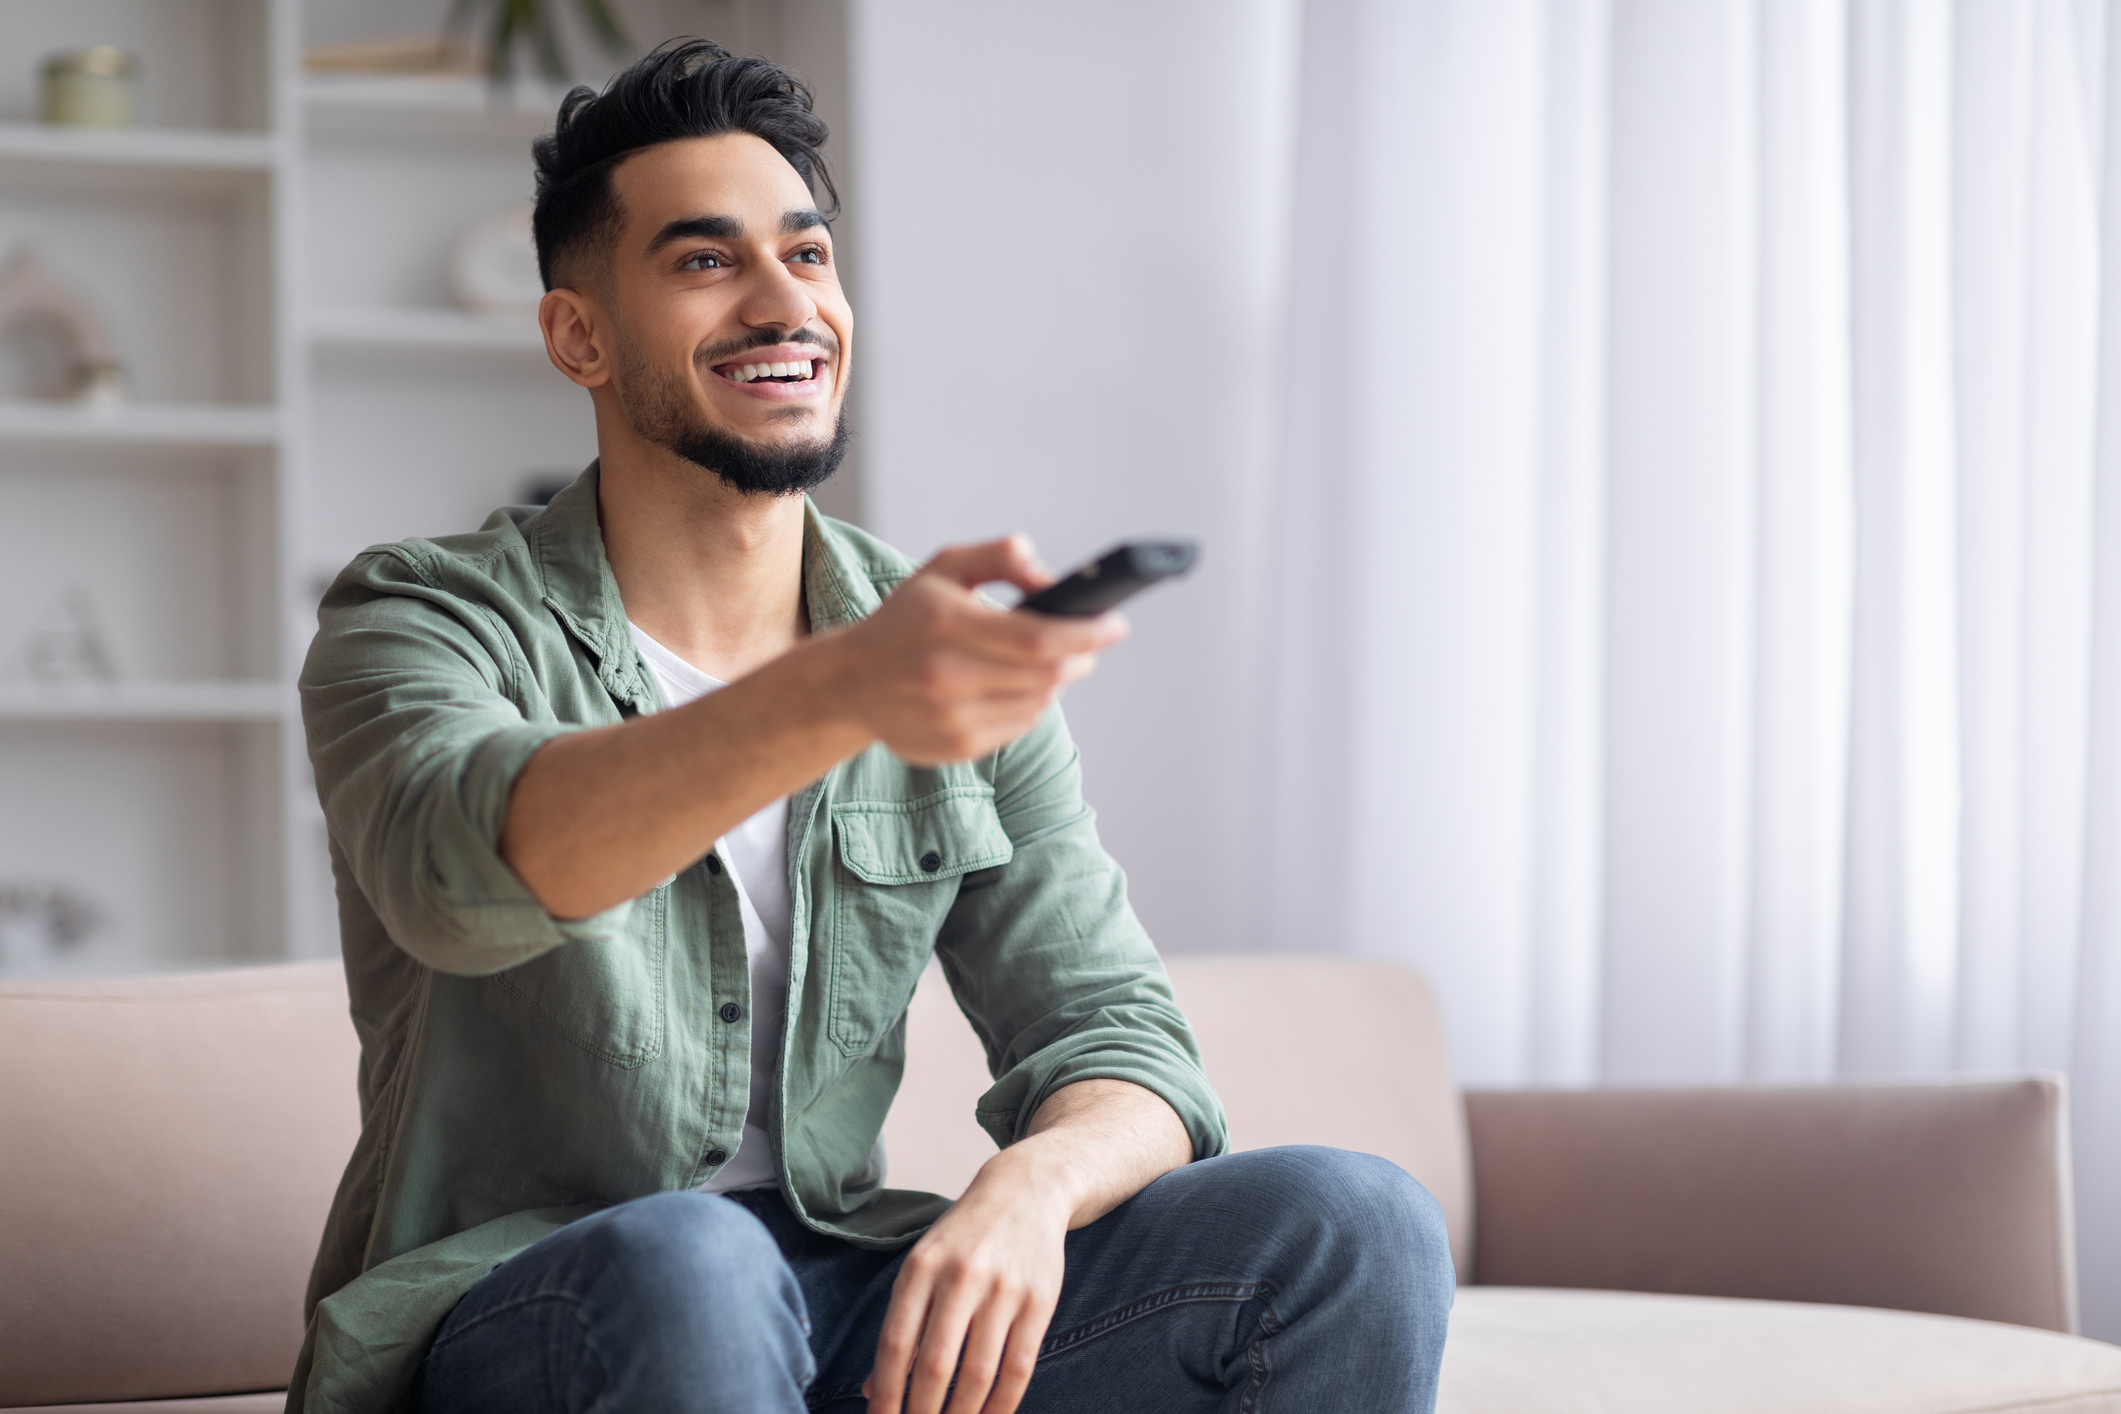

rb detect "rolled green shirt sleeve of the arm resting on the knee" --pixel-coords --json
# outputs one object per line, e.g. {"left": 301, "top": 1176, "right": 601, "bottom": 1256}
{"left": 935, "top": 708, "right": 1228, "bottom": 1160}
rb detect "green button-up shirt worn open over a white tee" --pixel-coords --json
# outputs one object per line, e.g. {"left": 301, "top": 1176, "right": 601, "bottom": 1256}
{"left": 288, "top": 464, "right": 1226, "bottom": 1414}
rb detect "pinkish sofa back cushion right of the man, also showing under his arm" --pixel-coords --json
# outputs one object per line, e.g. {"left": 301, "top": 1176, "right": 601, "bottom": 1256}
{"left": 884, "top": 956, "right": 1472, "bottom": 1280}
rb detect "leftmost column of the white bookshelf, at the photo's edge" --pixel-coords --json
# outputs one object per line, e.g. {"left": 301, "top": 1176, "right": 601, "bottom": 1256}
{"left": 0, "top": 0, "right": 299, "bottom": 977}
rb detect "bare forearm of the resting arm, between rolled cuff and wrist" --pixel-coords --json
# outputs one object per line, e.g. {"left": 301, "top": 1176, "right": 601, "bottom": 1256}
{"left": 980, "top": 1079, "right": 1192, "bottom": 1230}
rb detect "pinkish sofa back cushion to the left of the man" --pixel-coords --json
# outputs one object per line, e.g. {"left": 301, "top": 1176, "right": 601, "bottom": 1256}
{"left": 0, "top": 962, "right": 358, "bottom": 1414}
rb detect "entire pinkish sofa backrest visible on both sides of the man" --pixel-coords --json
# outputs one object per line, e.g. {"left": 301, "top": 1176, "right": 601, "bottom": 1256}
{"left": 0, "top": 958, "right": 1472, "bottom": 1408}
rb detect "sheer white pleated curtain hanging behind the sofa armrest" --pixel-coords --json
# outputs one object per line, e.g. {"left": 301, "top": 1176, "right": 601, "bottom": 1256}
{"left": 1264, "top": 0, "right": 2121, "bottom": 1338}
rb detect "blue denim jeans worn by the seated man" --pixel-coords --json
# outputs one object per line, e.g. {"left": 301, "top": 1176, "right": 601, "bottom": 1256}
{"left": 416, "top": 1147, "right": 1453, "bottom": 1414}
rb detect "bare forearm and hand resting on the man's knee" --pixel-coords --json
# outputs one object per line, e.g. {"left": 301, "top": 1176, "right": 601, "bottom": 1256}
{"left": 865, "top": 1079, "right": 1192, "bottom": 1414}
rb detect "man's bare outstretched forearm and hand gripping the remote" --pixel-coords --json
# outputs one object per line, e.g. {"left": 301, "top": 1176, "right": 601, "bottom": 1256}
{"left": 501, "top": 536, "right": 1126, "bottom": 918}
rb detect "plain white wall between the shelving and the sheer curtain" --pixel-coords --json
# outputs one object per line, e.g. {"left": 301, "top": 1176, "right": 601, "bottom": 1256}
{"left": 851, "top": 0, "right": 1294, "bottom": 952}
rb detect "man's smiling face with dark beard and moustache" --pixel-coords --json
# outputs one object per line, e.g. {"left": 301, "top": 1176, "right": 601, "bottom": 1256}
{"left": 611, "top": 134, "right": 855, "bottom": 494}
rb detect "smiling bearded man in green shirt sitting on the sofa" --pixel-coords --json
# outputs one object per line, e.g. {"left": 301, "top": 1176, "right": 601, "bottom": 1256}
{"left": 288, "top": 42, "right": 1451, "bottom": 1414}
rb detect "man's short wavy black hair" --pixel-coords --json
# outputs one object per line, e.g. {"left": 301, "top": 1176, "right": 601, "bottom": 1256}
{"left": 530, "top": 40, "right": 840, "bottom": 290}
